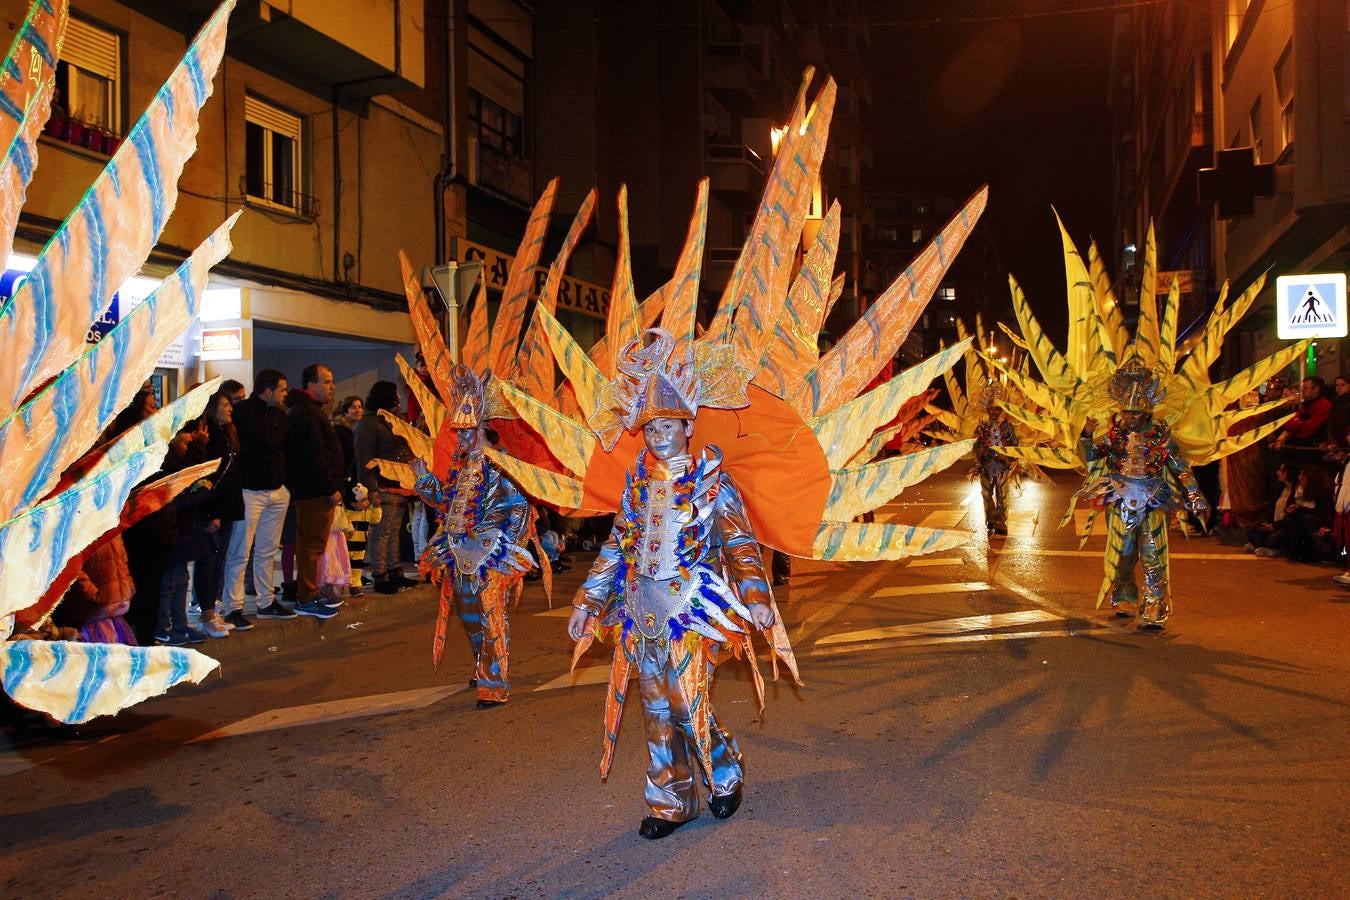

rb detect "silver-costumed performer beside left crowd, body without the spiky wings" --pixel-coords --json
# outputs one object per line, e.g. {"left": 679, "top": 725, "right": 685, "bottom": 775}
{"left": 417, "top": 366, "right": 535, "bottom": 710}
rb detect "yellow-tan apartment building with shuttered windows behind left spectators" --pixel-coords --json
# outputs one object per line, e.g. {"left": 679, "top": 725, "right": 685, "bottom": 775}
{"left": 0, "top": 0, "right": 441, "bottom": 397}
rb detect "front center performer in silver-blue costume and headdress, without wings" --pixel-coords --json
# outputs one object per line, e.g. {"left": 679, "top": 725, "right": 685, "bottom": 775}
{"left": 568, "top": 335, "right": 775, "bottom": 839}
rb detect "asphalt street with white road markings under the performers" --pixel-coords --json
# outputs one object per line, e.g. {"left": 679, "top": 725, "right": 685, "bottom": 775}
{"left": 0, "top": 475, "right": 1350, "bottom": 897}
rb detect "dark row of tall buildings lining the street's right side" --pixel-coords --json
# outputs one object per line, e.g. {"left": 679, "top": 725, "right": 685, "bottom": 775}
{"left": 1103, "top": 0, "right": 1350, "bottom": 379}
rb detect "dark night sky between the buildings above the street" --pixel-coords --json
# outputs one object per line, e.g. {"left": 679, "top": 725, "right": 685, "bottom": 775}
{"left": 864, "top": 0, "right": 1114, "bottom": 337}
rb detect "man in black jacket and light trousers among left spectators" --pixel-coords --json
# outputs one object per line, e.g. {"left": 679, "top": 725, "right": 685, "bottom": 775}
{"left": 225, "top": 368, "right": 296, "bottom": 630}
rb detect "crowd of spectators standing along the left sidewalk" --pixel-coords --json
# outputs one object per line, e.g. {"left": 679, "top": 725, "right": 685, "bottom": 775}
{"left": 35, "top": 363, "right": 433, "bottom": 646}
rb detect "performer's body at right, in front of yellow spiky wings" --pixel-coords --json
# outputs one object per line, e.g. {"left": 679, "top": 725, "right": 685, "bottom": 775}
{"left": 1080, "top": 354, "right": 1210, "bottom": 630}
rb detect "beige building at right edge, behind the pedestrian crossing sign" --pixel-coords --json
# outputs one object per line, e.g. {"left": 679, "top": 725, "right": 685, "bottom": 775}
{"left": 1212, "top": 0, "right": 1350, "bottom": 381}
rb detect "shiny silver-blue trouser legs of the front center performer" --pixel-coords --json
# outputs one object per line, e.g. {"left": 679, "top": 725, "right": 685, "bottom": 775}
{"left": 637, "top": 641, "right": 743, "bottom": 822}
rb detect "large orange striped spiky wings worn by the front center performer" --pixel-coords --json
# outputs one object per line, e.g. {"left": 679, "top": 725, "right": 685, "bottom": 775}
{"left": 469, "top": 72, "right": 987, "bottom": 768}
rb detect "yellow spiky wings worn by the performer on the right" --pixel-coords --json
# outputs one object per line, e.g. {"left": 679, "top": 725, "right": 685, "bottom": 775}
{"left": 996, "top": 214, "right": 1307, "bottom": 615}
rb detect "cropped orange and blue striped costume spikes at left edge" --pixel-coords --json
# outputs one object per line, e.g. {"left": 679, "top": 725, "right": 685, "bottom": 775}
{"left": 0, "top": 0, "right": 238, "bottom": 723}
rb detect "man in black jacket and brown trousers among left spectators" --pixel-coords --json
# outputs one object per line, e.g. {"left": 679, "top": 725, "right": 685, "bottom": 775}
{"left": 286, "top": 363, "right": 347, "bottom": 619}
